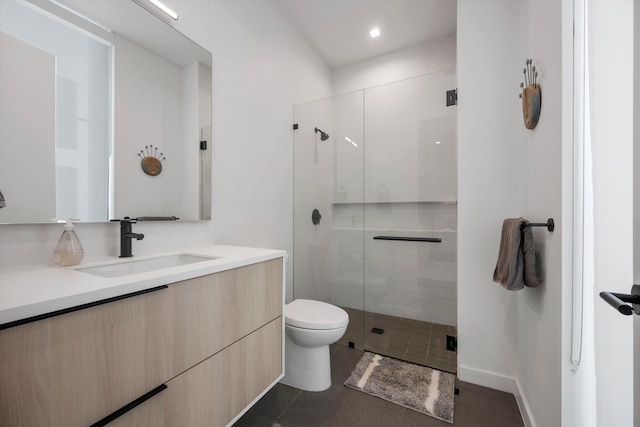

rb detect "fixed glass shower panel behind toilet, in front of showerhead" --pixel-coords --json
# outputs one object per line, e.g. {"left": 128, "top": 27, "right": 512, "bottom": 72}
{"left": 293, "top": 91, "right": 364, "bottom": 349}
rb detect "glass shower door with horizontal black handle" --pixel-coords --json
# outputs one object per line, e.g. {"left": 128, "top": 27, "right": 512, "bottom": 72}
{"left": 364, "top": 69, "right": 457, "bottom": 372}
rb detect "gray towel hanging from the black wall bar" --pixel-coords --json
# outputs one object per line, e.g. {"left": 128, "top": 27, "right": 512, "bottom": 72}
{"left": 493, "top": 218, "right": 542, "bottom": 291}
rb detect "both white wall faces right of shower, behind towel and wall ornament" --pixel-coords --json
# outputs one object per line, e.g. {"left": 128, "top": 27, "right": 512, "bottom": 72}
{"left": 458, "top": 0, "right": 562, "bottom": 426}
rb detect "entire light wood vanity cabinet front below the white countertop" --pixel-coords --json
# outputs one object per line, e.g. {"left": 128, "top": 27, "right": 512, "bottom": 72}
{"left": 0, "top": 258, "right": 282, "bottom": 427}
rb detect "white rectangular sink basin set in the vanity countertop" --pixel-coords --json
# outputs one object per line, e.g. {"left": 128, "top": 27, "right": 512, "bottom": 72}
{"left": 78, "top": 254, "right": 220, "bottom": 277}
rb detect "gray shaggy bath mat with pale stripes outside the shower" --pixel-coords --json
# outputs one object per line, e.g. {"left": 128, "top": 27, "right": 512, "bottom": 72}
{"left": 344, "top": 352, "right": 455, "bottom": 423}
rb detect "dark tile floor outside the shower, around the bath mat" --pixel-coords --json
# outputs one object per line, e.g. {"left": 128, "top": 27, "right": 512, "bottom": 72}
{"left": 234, "top": 345, "right": 524, "bottom": 427}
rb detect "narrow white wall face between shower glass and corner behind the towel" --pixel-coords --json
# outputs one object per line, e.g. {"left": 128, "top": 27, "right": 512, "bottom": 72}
{"left": 457, "top": 0, "right": 524, "bottom": 391}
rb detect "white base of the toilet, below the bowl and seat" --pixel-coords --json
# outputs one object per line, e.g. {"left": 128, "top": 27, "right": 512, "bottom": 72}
{"left": 280, "top": 334, "right": 331, "bottom": 391}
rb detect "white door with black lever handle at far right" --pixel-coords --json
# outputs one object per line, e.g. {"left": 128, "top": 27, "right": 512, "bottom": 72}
{"left": 587, "top": 0, "right": 640, "bottom": 427}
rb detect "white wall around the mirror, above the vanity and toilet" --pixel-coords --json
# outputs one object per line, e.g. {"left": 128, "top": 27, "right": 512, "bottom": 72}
{"left": 0, "top": 1, "right": 331, "bottom": 298}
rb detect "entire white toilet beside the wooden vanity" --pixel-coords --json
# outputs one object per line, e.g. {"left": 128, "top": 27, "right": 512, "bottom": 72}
{"left": 281, "top": 299, "right": 349, "bottom": 391}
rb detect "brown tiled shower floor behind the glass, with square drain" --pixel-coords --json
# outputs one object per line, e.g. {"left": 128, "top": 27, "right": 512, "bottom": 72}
{"left": 338, "top": 307, "right": 458, "bottom": 374}
